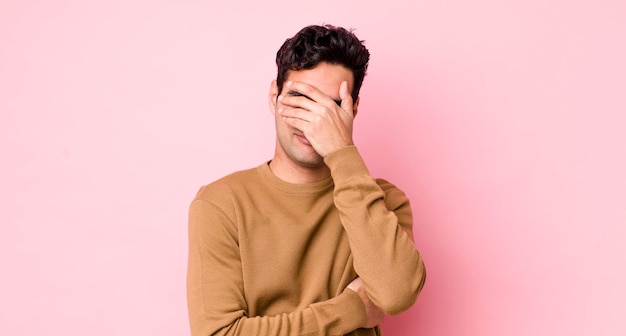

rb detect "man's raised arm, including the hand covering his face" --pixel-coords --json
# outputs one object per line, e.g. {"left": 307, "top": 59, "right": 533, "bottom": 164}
{"left": 279, "top": 81, "right": 426, "bottom": 315}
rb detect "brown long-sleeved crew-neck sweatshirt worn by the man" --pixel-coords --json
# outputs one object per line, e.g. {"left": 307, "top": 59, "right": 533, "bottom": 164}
{"left": 187, "top": 146, "right": 426, "bottom": 336}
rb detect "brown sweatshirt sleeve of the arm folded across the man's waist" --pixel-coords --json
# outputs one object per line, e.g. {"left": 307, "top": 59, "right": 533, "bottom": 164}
{"left": 187, "top": 199, "right": 365, "bottom": 336}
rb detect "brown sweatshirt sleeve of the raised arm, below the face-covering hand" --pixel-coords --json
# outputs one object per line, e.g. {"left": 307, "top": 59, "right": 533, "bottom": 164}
{"left": 325, "top": 146, "right": 426, "bottom": 315}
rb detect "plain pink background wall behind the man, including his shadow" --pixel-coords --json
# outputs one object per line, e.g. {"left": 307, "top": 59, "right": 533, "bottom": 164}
{"left": 0, "top": 0, "right": 626, "bottom": 336}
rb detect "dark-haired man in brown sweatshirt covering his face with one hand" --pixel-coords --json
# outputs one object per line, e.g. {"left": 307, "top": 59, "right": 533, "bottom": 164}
{"left": 187, "top": 25, "right": 425, "bottom": 336}
